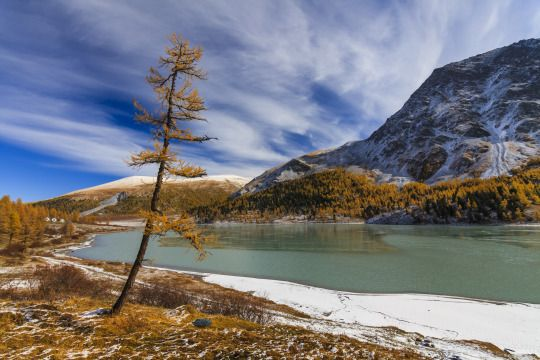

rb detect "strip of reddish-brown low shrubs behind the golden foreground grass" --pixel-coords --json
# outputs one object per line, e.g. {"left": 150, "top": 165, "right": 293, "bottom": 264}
{"left": 0, "top": 265, "right": 272, "bottom": 324}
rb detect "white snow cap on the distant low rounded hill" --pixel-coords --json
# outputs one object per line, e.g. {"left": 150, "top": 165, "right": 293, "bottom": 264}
{"left": 66, "top": 175, "right": 250, "bottom": 195}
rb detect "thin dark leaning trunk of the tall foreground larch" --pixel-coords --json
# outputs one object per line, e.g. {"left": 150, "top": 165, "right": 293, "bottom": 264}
{"left": 111, "top": 72, "right": 177, "bottom": 315}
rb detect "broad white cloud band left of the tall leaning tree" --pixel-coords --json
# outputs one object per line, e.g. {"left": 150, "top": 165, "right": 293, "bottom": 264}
{"left": 0, "top": 89, "right": 146, "bottom": 175}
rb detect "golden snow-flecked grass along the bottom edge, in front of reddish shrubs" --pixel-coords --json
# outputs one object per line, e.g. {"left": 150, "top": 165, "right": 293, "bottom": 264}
{"left": 0, "top": 297, "right": 421, "bottom": 359}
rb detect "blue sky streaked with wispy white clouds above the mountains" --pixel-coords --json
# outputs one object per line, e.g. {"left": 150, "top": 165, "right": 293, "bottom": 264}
{"left": 0, "top": 0, "right": 540, "bottom": 201}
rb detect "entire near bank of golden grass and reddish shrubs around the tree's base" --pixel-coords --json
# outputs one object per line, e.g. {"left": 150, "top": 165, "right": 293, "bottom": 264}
{"left": 0, "top": 265, "right": 428, "bottom": 359}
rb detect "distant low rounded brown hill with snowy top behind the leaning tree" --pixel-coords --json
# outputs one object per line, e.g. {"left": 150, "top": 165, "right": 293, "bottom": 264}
{"left": 36, "top": 175, "right": 248, "bottom": 215}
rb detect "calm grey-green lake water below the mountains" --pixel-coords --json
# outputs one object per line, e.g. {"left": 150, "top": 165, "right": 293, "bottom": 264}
{"left": 74, "top": 224, "right": 540, "bottom": 303}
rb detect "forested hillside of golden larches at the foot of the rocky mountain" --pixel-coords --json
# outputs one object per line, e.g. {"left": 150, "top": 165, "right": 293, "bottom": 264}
{"left": 194, "top": 161, "right": 540, "bottom": 223}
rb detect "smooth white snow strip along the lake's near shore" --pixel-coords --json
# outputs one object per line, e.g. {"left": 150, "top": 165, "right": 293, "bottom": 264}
{"left": 204, "top": 274, "right": 540, "bottom": 355}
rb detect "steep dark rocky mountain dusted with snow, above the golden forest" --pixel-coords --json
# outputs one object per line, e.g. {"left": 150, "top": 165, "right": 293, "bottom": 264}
{"left": 240, "top": 39, "right": 540, "bottom": 193}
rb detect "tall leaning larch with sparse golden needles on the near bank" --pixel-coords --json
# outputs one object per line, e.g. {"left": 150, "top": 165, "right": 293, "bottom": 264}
{"left": 111, "top": 34, "right": 211, "bottom": 314}
